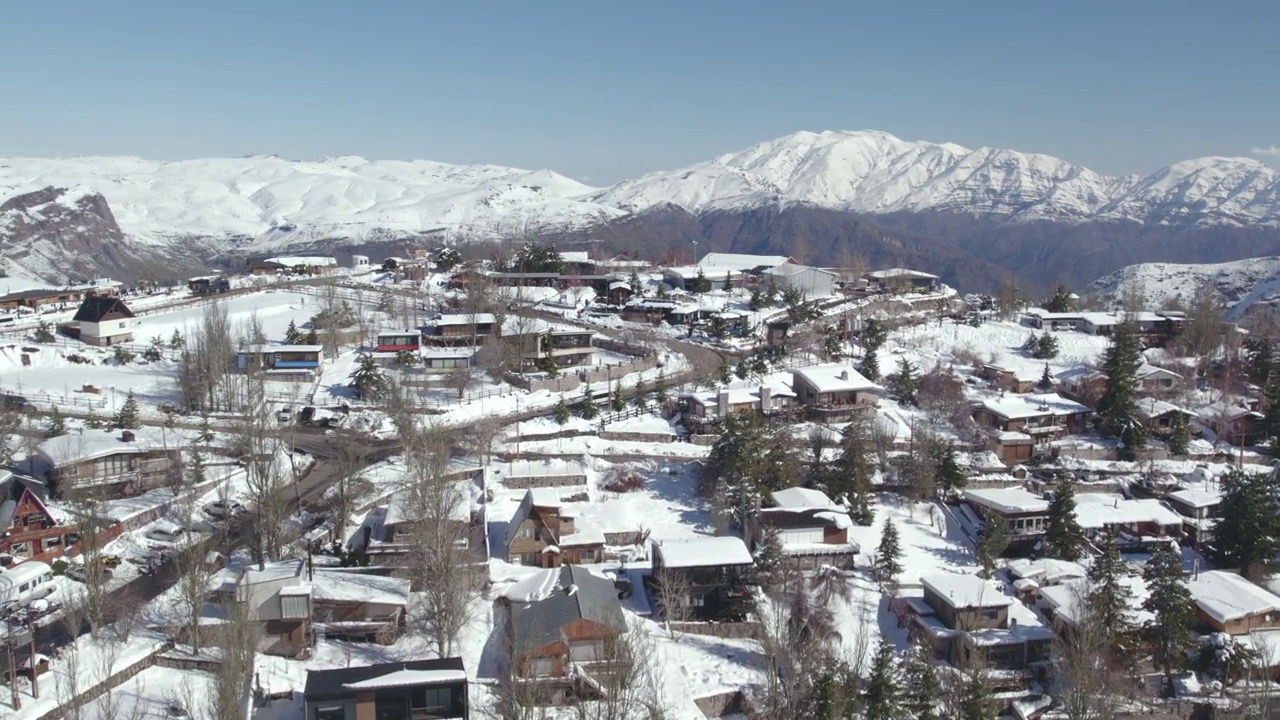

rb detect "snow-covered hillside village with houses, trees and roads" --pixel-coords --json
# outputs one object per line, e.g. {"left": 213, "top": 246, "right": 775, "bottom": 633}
{"left": 0, "top": 243, "right": 1280, "bottom": 720}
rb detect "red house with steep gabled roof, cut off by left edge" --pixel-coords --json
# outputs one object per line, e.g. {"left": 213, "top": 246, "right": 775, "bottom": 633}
{"left": 0, "top": 469, "right": 78, "bottom": 566}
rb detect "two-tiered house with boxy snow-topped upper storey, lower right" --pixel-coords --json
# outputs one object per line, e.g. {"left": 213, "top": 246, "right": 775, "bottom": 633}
{"left": 908, "top": 573, "right": 1053, "bottom": 670}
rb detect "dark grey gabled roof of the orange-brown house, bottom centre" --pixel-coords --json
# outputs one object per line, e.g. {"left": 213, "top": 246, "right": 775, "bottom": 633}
{"left": 511, "top": 565, "right": 625, "bottom": 655}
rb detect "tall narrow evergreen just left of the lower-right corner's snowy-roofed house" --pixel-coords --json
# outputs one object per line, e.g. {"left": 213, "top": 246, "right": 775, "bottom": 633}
{"left": 1142, "top": 544, "right": 1196, "bottom": 694}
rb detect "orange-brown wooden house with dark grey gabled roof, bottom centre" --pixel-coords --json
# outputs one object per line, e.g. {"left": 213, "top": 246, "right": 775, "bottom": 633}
{"left": 499, "top": 565, "right": 626, "bottom": 678}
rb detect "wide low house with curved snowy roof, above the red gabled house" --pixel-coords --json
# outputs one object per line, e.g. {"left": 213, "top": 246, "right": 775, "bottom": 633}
{"left": 36, "top": 428, "right": 183, "bottom": 498}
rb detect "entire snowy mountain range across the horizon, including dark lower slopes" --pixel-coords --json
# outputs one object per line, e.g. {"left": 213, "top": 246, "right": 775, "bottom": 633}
{"left": 0, "top": 131, "right": 1280, "bottom": 290}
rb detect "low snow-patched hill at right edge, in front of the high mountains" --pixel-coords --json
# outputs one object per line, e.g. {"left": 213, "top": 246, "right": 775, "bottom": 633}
{"left": 1089, "top": 258, "right": 1280, "bottom": 319}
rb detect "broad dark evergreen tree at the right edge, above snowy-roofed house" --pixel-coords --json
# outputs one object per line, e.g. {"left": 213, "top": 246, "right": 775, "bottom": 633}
{"left": 1208, "top": 468, "right": 1280, "bottom": 573}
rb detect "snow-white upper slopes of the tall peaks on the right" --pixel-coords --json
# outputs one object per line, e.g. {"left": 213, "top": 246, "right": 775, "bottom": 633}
{"left": 594, "top": 131, "right": 1280, "bottom": 224}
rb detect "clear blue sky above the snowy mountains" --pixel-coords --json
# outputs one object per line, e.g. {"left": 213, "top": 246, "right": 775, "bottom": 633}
{"left": 0, "top": 0, "right": 1280, "bottom": 184}
